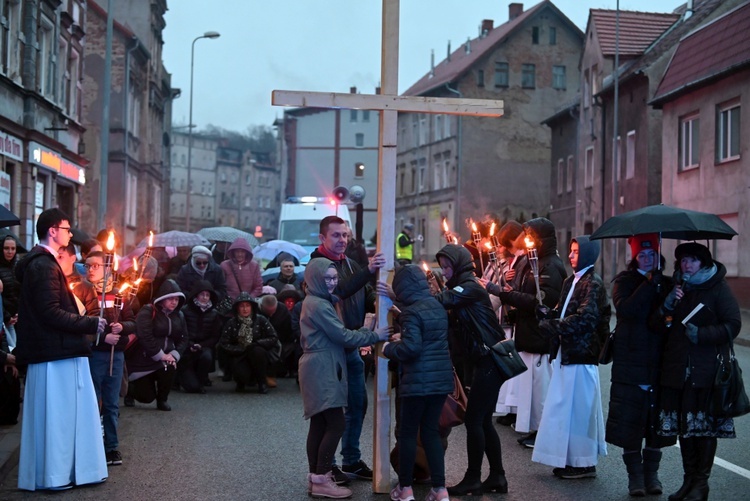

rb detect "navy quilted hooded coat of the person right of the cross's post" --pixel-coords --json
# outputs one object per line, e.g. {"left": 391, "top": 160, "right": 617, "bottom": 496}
{"left": 383, "top": 264, "right": 454, "bottom": 397}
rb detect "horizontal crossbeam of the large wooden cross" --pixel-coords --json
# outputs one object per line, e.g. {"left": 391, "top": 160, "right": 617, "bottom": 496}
{"left": 271, "top": 88, "right": 504, "bottom": 117}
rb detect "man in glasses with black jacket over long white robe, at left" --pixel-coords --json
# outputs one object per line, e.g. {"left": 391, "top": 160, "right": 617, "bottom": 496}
{"left": 16, "top": 208, "right": 107, "bottom": 491}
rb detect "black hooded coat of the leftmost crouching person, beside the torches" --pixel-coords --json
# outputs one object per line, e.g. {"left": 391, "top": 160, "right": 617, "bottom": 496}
{"left": 127, "top": 279, "right": 188, "bottom": 381}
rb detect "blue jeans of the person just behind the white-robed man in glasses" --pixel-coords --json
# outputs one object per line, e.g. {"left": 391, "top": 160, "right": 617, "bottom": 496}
{"left": 89, "top": 351, "right": 125, "bottom": 452}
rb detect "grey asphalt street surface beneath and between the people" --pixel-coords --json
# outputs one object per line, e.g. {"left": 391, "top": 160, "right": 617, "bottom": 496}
{"left": 0, "top": 346, "right": 750, "bottom": 501}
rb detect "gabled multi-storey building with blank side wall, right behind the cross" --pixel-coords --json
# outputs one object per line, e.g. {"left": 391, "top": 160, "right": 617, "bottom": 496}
{"left": 396, "top": 0, "right": 583, "bottom": 257}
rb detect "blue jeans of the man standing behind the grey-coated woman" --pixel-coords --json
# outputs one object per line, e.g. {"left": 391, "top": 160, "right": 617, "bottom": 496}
{"left": 341, "top": 349, "right": 367, "bottom": 465}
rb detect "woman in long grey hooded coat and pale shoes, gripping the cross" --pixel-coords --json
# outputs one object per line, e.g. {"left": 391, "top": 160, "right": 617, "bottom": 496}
{"left": 299, "top": 258, "right": 391, "bottom": 498}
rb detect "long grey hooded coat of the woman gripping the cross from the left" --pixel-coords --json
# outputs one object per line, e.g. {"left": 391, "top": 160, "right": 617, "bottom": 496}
{"left": 299, "top": 258, "right": 378, "bottom": 419}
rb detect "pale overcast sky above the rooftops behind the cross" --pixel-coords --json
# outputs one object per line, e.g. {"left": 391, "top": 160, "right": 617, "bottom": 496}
{"left": 163, "top": 0, "right": 683, "bottom": 132}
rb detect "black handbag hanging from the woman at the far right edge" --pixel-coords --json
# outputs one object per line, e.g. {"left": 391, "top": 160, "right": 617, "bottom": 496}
{"left": 711, "top": 337, "right": 750, "bottom": 418}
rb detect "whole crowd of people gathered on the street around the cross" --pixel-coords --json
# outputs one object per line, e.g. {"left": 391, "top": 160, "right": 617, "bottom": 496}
{"left": 0, "top": 209, "right": 740, "bottom": 501}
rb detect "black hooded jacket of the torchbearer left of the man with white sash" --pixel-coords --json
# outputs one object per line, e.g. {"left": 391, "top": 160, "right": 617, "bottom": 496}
{"left": 497, "top": 217, "right": 566, "bottom": 354}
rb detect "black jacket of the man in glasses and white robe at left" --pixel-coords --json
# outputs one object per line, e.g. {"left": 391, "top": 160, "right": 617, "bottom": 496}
{"left": 15, "top": 246, "right": 99, "bottom": 365}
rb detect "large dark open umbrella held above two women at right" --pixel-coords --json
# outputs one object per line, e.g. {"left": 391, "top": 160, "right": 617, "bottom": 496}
{"left": 591, "top": 204, "right": 737, "bottom": 240}
